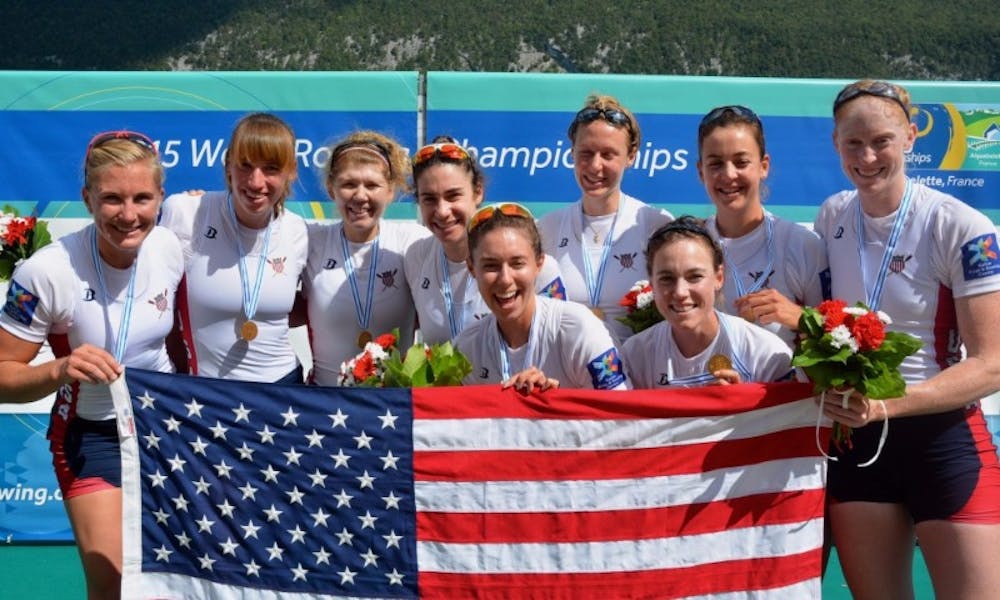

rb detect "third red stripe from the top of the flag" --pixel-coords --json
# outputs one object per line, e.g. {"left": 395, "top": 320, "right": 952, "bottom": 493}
{"left": 417, "top": 488, "right": 825, "bottom": 544}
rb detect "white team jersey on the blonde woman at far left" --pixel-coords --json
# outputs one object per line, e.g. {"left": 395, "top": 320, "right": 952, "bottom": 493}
{"left": 0, "top": 225, "right": 184, "bottom": 421}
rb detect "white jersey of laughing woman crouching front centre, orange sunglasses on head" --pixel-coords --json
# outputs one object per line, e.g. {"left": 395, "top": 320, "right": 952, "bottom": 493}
{"left": 455, "top": 296, "right": 627, "bottom": 390}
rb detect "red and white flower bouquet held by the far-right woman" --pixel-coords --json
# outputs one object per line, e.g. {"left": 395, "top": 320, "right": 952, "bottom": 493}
{"left": 792, "top": 300, "right": 922, "bottom": 466}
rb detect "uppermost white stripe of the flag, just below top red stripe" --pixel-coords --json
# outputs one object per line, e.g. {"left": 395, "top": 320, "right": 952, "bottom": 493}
{"left": 413, "top": 398, "right": 819, "bottom": 452}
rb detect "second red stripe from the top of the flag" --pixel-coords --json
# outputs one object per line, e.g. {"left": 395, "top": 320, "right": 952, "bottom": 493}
{"left": 413, "top": 427, "right": 816, "bottom": 481}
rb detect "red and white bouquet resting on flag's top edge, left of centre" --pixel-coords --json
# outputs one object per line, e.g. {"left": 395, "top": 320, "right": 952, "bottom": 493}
{"left": 339, "top": 329, "right": 472, "bottom": 387}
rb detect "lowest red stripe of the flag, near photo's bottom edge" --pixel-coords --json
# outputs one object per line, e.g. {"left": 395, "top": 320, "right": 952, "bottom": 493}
{"left": 419, "top": 548, "right": 821, "bottom": 600}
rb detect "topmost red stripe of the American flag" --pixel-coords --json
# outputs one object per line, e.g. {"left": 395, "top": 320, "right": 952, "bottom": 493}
{"left": 413, "top": 383, "right": 813, "bottom": 420}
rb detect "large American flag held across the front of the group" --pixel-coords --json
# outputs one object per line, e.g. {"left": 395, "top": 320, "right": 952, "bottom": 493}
{"left": 113, "top": 369, "right": 826, "bottom": 599}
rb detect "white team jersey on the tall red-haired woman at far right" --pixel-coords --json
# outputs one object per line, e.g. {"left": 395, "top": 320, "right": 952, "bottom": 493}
{"left": 815, "top": 182, "right": 1000, "bottom": 382}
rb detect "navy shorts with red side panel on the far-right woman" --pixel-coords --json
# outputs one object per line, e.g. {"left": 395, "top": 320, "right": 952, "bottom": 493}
{"left": 827, "top": 405, "right": 1000, "bottom": 523}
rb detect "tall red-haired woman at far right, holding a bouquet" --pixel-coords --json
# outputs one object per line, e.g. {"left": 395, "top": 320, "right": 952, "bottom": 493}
{"left": 816, "top": 80, "right": 1000, "bottom": 599}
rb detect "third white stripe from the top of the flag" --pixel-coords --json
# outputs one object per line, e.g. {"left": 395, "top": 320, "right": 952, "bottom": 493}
{"left": 417, "top": 518, "right": 823, "bottom": 574}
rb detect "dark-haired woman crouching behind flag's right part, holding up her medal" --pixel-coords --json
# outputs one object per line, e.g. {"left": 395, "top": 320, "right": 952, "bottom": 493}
{"left": 622, "top": 217, "right": 792, "bottom": 389}
